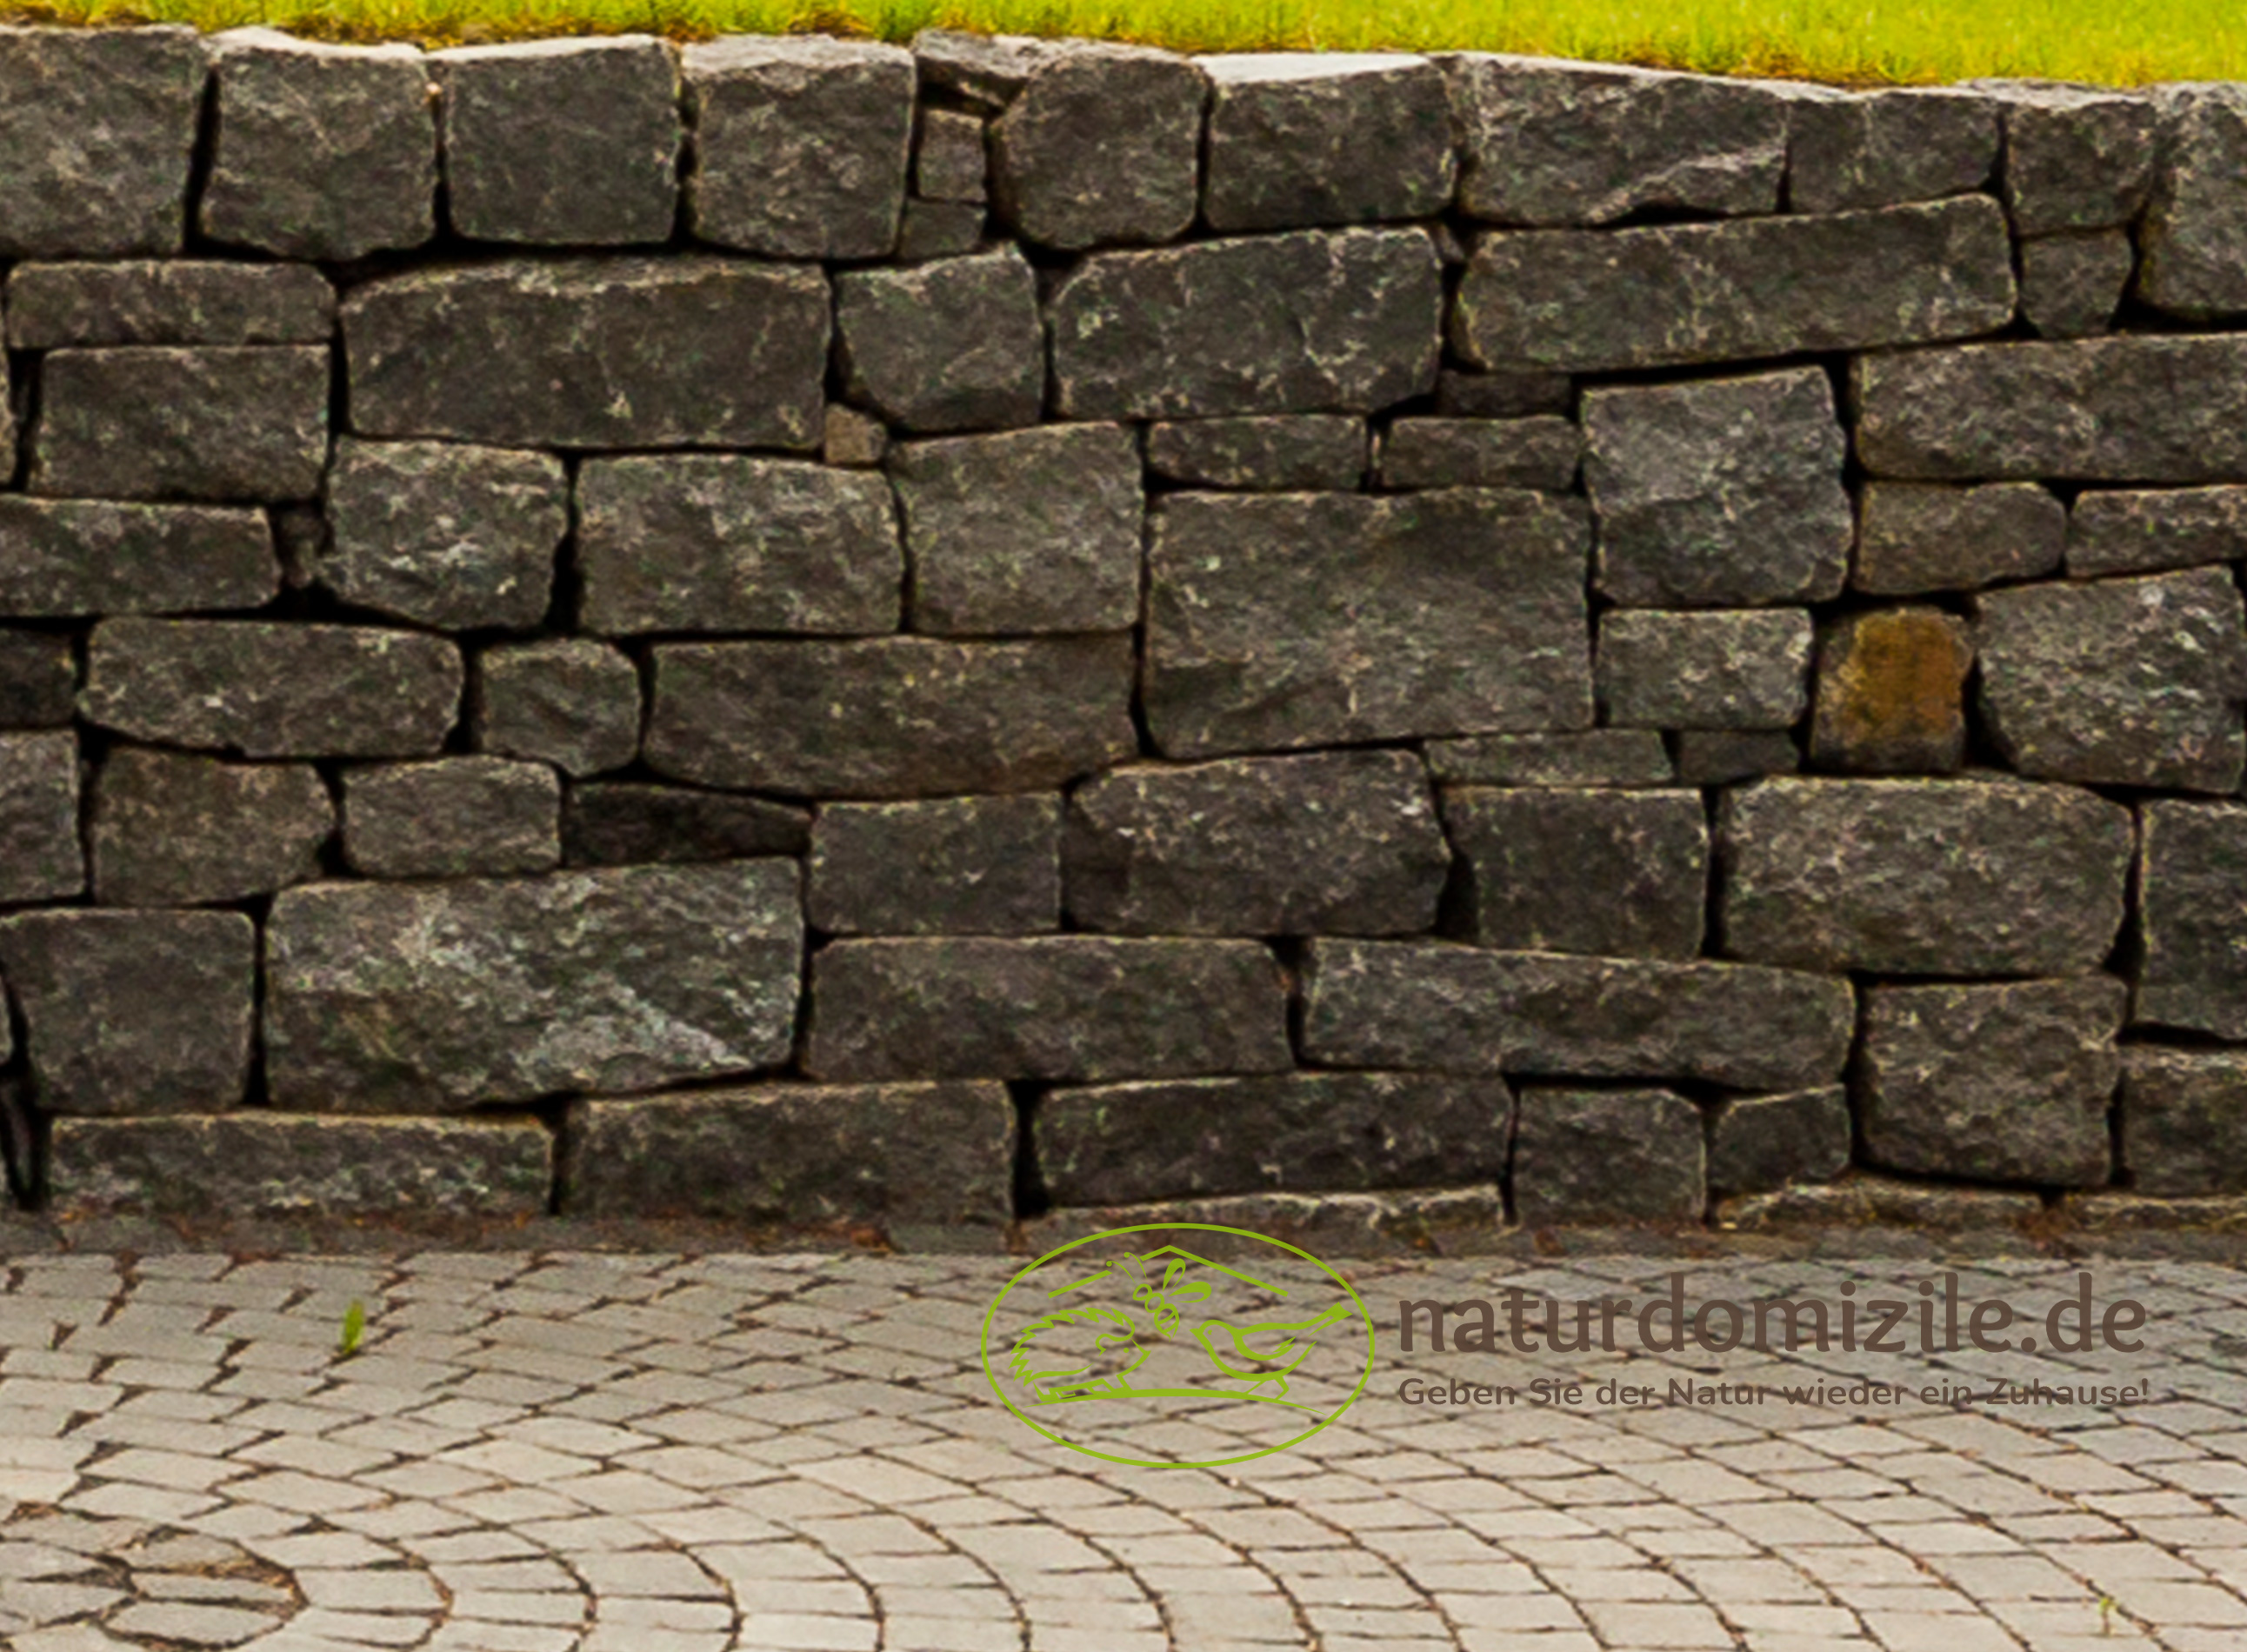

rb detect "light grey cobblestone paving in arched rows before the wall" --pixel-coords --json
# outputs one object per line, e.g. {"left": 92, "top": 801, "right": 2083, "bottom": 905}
{"left": 0, "top": 1252, "right": 2247, "bottom": 1652}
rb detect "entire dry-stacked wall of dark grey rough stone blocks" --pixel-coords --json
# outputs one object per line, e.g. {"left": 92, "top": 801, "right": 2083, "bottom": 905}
{"left": 0, "top": 30, "right": 2247, "bottom": 1243}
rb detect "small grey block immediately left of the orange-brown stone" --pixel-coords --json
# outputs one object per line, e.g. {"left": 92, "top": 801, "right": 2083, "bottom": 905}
{"left": 1593, "top": 610, "right": 1813, "bottom": 729}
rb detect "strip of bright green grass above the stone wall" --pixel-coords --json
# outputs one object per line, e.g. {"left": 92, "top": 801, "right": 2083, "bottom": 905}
{"left": 16, "top": 0, "right": 2247, "bottom": 85}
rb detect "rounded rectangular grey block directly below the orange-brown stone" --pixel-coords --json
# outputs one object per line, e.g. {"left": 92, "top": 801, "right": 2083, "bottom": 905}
{"left": 1717, "top": 780, "right": 2130, "bottom": 976}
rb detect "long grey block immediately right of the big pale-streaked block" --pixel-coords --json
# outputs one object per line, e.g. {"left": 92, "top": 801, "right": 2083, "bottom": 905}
{"left": 804, "top": 935, "right": 1292, "bottom": 1081}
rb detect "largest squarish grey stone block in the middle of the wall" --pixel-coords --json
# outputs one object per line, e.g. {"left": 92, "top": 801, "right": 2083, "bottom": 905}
{"left": 1144, "top": 488, "right": 1590, "bottom": 757}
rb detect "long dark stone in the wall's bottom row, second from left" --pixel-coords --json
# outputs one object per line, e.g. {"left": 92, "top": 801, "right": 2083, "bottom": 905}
{"left": 562, "top": 1083, "right": 1016, "bottom": 1236}
